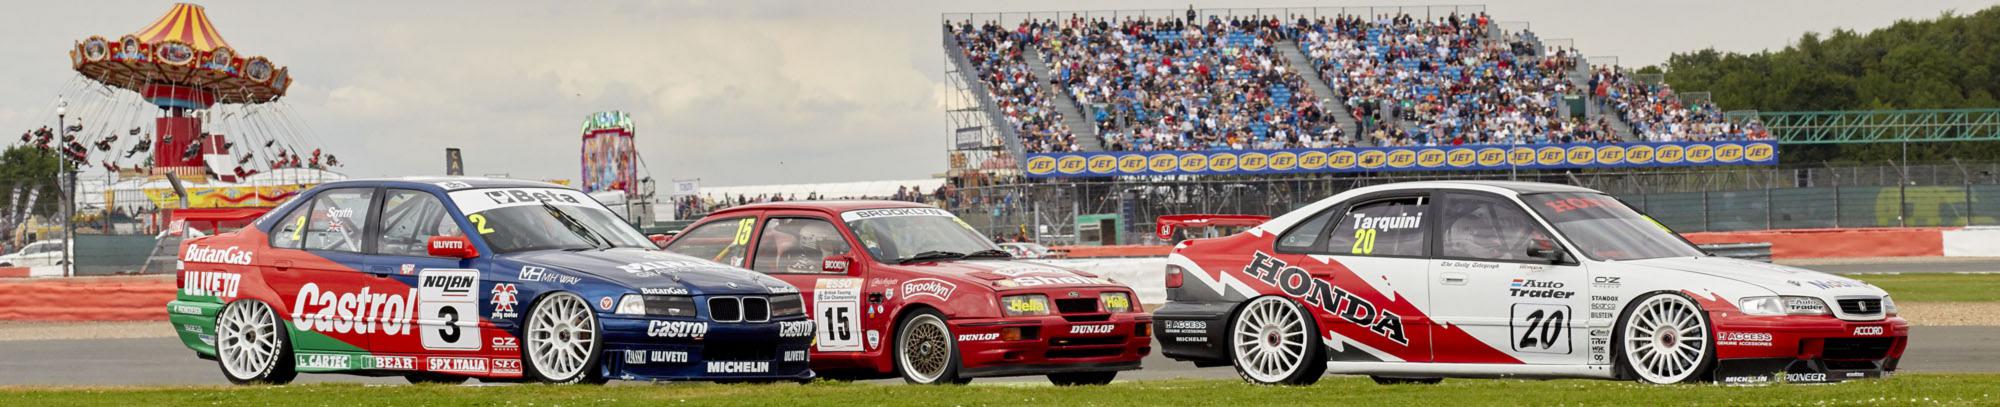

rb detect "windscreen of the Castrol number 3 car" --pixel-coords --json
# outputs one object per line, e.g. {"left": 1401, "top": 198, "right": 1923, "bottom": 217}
{"left": 452, "top": 188, "right": 654, "bottom": 253}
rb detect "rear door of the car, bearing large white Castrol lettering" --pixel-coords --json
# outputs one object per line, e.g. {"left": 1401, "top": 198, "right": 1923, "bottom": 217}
{"left": 258, "top": 188, "right": 386, "bottom": 351}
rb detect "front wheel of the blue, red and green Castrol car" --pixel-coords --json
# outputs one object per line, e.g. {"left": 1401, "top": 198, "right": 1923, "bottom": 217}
{"left": 520, "top": 293, "right": 604, "bottom": 385}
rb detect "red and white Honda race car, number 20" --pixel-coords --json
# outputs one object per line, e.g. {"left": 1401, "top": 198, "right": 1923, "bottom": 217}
{"left": 1154, "top": 182, "right": 1910, "bottom": 385}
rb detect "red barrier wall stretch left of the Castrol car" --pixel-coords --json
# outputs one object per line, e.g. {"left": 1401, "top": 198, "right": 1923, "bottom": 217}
{"left": 0, "top": 275, "right": 174, "bottom": 321}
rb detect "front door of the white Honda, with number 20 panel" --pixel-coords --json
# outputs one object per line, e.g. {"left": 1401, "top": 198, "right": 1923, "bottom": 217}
{"left": 1430, "top": 192, "right": 1584, "bottom": 365}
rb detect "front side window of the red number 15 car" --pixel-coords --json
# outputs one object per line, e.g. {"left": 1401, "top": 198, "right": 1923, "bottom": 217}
{"left": 750, "top": 217, "right": 848, "bottom": 273}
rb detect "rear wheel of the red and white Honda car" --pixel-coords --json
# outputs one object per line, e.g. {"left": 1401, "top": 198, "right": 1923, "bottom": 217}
{"left": 1230, "top": 297, "right": 1326, "bottom": 385}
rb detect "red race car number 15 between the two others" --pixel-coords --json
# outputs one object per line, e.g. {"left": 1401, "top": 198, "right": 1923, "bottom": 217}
{"left": 666, "top": 202, "right": 1152, "bottom": 385}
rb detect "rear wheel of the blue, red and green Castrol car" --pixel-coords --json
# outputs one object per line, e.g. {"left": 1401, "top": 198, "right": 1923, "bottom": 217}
{"left": 216, "top": 299, "right": 298, "bottom": 385}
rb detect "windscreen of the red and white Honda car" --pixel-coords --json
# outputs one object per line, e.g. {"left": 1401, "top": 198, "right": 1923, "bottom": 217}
{"left": 1522, "top": 192, "right": 1702, "bottom": 259}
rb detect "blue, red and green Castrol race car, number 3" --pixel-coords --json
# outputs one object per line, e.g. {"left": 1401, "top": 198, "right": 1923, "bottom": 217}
{"left": 166, "top": 178, "right": 812, "bottom": 383}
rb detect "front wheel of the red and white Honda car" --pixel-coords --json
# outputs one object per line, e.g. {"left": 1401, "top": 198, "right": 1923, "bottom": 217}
{"left": 1612, "top": 293, "right": 1716, "bottom": 385}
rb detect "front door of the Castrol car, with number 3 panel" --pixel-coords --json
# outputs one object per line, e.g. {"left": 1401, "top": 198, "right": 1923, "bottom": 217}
{"left": 366, "top": 188, "right": 484, "bottom": 353}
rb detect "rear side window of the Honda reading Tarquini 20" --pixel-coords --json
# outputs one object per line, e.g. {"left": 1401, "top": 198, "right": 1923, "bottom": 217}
{"left": 1326, "top": 196, "right": 1430, "bottom": 257}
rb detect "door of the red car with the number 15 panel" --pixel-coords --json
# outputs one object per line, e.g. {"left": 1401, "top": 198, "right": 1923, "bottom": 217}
{"left": 750, "top": 211, "right": 864, "bottom": 353}
